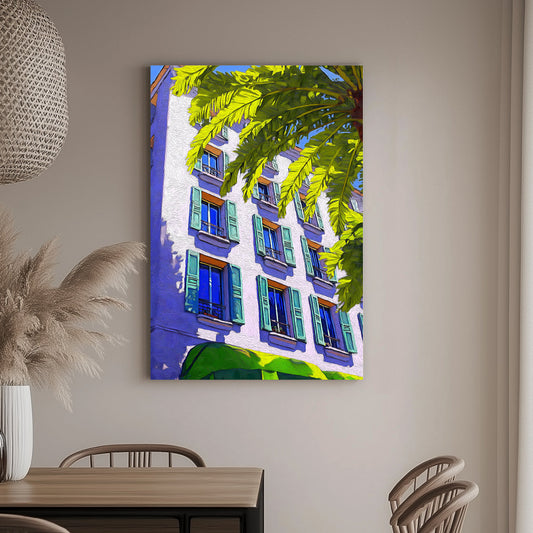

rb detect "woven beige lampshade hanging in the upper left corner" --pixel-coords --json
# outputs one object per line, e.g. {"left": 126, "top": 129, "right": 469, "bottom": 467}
{"left": 0, "top": 0, "right": 68, "bottom": 183}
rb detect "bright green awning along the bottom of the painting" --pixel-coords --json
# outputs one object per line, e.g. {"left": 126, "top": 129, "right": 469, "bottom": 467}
{"left": 180, "top": 342, "right": 362, "bottom": 380}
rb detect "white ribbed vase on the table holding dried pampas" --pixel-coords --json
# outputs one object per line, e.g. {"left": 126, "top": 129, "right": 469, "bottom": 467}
{"left": 0, "top": 385, "right": 33, "bottom": 481}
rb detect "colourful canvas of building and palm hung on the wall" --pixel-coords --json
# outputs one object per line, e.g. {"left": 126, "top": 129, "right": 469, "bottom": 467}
{"left": 150, "top": 65, "right": 363, "bottom": 380}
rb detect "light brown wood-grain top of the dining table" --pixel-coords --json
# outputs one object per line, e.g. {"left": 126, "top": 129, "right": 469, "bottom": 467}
{"left": 0, "top": 467, "right": 263, "bottom": 508}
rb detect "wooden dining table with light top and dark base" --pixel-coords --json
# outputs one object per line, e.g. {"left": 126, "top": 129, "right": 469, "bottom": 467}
{"left": 0, "top": 467, "right": 264, "bottom": 533}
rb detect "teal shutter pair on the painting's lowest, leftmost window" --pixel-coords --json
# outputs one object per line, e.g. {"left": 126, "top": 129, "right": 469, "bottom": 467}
{"left": 185, "top": 250, "right": 243, "bottom": 324}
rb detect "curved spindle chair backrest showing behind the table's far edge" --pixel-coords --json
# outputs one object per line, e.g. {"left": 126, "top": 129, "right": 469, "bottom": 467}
{"left": 59, "top": 444, "right": 205, "bottom": 468}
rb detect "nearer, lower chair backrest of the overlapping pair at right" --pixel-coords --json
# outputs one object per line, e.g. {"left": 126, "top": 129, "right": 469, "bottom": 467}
{"left": 398, "top": 481, "right": 479, "bottom": 533}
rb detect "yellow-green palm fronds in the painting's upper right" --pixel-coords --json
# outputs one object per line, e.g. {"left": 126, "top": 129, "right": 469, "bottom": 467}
{"left": 172, "top": 65, "right": 363, "bottom": 311}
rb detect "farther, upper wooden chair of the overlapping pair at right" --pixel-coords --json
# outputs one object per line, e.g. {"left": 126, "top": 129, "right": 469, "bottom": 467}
{"left": 389, "top": 455, "right": 465, "bottom": 533}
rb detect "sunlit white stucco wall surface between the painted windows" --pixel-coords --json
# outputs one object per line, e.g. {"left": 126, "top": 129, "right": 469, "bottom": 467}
{"left": 157, "top": 90, "right": 363, "bottom": 376}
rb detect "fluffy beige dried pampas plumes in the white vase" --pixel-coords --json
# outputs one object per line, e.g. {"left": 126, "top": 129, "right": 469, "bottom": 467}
{"left": 0, "top": 212, "right": 144, "bottom": 409}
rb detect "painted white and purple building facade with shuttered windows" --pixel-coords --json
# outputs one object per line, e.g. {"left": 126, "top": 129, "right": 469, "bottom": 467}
{"left": 151, "top": 66, "right": 363, "bottom": 379}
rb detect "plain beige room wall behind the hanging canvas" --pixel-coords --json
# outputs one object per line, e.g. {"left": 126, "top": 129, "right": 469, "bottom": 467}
{"left": 0, "top": 0, "right": 510, "bottom": 533}
